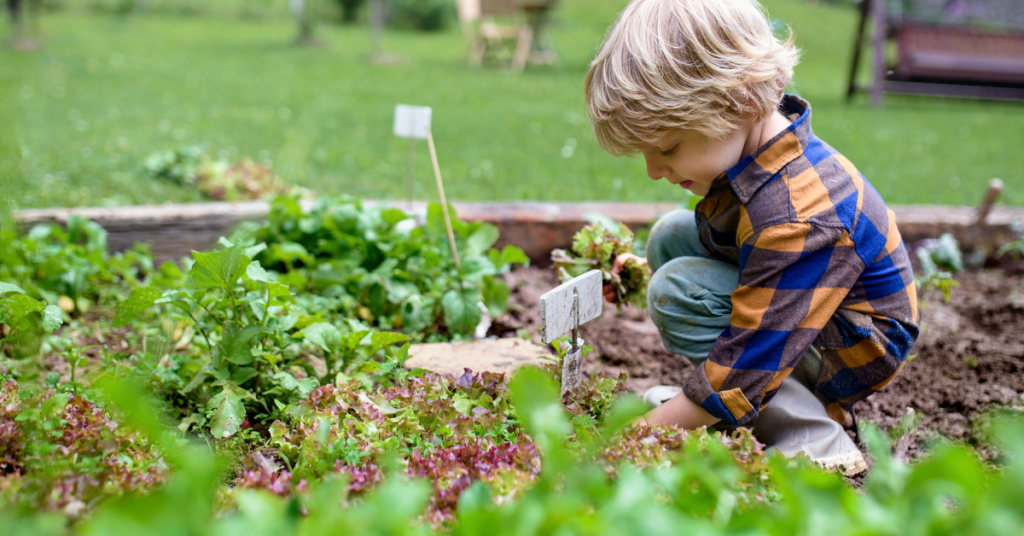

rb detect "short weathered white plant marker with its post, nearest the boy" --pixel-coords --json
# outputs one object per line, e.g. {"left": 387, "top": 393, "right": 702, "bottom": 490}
{"left": 541, "top": 270, "right": 604, "bottom": 395}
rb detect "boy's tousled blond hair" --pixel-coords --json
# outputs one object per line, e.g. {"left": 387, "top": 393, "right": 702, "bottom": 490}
{"left": 585, "top": 0, "right": 800, "bottom": 156}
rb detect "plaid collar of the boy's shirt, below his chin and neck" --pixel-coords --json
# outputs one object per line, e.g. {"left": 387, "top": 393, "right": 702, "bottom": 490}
{"left": 712, "top": 95, "right": 813, "bottom": 205}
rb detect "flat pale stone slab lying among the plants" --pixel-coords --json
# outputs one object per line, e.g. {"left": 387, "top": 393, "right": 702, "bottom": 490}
{"left": 406, "top": 338, "right": 554, "bottom": 376}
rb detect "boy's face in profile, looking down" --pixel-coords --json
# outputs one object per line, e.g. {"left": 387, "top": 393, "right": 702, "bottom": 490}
{"left": 641, "top": 128, "right": 751, "bottom": 196}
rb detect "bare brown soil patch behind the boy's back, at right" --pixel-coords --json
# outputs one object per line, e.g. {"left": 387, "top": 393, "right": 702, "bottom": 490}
{"left": 856, "top": 270, "right": 1024, "bottom": 459}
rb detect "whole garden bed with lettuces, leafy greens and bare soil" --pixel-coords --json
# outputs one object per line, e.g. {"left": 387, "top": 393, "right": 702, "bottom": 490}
{"left": 6, "top": 198, "right": 1024, "bottom": 536}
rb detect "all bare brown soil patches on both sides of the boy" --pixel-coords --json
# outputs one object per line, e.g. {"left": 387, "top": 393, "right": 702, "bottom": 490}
{"left": 494, "top": 267, "right": 1024, "bottom": 459}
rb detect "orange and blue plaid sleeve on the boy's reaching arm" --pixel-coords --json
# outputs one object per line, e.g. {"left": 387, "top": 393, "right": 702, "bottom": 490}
{"left": 683, "top": 222, "right": 864, "bottom": 424}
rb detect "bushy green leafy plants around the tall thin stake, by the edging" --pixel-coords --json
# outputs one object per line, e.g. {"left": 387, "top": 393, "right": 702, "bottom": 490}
{"left": 237, "top": 197, "right": 529, "bottom": 340}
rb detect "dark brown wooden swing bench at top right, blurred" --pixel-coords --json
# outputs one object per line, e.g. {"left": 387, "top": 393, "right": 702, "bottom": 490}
{"left": 847, "top": 0, "right": 1024, "bottom": 106}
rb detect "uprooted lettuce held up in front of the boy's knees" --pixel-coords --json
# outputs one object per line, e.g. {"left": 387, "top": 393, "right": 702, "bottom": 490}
{"left": 551, "top": 222, "right": 650, "bottom": 308}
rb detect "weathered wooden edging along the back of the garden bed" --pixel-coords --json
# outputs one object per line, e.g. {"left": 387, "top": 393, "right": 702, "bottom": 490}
{"left": 15, "top": 201, "right": 1024, "bottom": 265}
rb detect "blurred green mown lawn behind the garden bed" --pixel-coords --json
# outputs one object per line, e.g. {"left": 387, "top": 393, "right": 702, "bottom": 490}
{"left": 0, "top": 0, "right": 1024, "bottom": 207}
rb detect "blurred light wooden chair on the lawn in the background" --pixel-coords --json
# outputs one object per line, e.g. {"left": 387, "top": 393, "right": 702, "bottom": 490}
{"left": 458, "top": 0, "right": 534, "bottom": 72}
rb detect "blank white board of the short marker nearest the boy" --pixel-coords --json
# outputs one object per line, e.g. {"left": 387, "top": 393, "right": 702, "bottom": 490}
{"left": 541, "top": 270, "right": 604, "bottom": 343}
